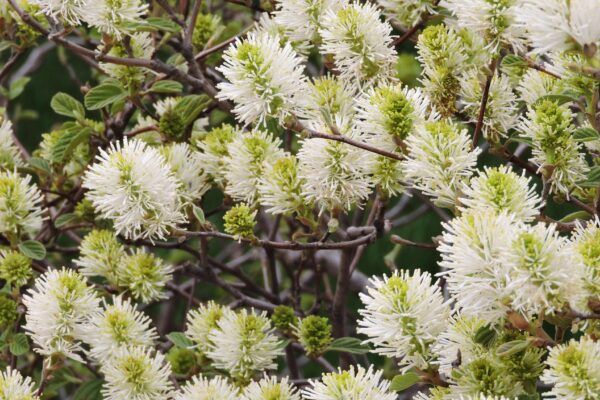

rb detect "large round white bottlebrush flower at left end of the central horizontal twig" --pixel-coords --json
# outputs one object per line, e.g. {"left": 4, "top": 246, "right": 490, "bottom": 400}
{"left": 83, "top": 139, "right": 186, "bottom": 239}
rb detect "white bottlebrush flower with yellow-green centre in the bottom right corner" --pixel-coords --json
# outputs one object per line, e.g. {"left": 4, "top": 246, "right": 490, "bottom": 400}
{"left": 542, "top": 337, "right": 600, "bottom": 400}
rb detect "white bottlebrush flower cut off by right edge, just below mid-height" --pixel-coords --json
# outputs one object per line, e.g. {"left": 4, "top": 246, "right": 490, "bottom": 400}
{"left": 568, "top": 217, "right": 600, "bottom": 314}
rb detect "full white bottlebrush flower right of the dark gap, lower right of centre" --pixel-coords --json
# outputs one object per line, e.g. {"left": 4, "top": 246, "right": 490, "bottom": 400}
{"left": 357, "top": 269, "right": 450, "bottom": 370}
